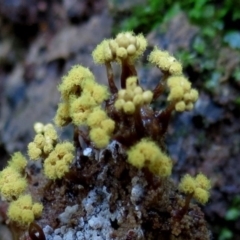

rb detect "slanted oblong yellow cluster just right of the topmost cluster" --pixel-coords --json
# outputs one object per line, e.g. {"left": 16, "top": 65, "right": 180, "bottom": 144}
{"left": 148, "top": 47, "right": 182, "bottom": 75}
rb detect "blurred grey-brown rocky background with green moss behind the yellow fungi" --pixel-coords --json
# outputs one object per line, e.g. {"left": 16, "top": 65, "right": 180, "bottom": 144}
{"left": 0, "top": 0, "right": 240, "bottom": 240}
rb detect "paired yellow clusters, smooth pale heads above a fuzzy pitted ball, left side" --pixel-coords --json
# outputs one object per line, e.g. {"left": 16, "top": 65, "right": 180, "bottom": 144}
{"left": 28, "top": 123, "right": 75, "bottom": 180}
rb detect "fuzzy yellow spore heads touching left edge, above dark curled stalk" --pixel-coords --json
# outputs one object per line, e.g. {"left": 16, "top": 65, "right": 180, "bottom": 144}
{"left": 0, "top": 152, "right": 43, "bottom": 227}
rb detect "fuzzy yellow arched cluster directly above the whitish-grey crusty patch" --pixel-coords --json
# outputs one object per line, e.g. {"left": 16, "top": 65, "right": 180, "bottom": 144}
{"left": 127, "top": 139, "right": 172, "bottom": 177}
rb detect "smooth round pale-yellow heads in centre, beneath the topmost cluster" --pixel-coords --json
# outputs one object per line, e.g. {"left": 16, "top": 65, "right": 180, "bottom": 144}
{"left": 115, "top": 77, "right": 153, "bottom": 114}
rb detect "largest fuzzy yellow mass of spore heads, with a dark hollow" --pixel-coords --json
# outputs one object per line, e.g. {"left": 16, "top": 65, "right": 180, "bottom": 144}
{"left": 54, "top": 65, "right": 115, "bottom": 148}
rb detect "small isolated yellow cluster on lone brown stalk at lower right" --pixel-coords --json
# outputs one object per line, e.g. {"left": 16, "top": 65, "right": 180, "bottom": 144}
{"left": 179, "top": 173, "right": 211, "bottom": 204}
